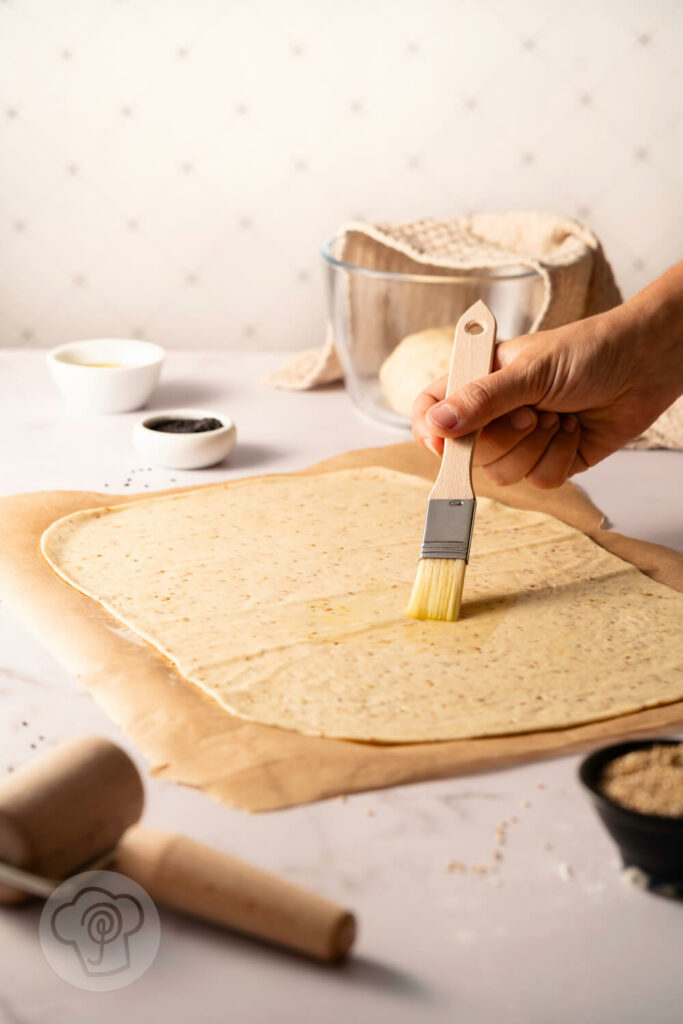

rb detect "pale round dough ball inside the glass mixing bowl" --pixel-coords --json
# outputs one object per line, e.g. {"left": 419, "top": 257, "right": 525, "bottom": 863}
{"left": 380, "top": 324, "right": 456, "bottom": 417}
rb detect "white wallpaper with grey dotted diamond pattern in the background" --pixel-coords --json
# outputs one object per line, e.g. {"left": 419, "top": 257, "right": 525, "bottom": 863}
{"left": 0, "top": 0, "right": 683, "bottom": 348}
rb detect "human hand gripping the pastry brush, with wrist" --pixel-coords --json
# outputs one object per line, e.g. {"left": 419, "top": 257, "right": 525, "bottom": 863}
{"left": 413, "top": 264, "right": 683, "bottom": 487}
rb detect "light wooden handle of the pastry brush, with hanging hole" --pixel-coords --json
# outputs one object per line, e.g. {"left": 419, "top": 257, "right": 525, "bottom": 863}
{"left": 429, "top": 300, "right": 496, "bottom": 499}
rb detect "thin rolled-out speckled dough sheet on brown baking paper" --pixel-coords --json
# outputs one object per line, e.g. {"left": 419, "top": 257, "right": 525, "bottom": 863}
{"left": 42, "top": 467, "right": 683, "bottom": 742}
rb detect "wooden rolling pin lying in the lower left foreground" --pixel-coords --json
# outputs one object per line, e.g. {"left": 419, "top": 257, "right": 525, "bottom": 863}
{"left": 0, "top": 737, "right": 355, "bottom": 961}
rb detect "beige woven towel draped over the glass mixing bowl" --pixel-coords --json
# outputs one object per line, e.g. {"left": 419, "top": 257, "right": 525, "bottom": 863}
{"left": 264, "top": 212, "right": 683, "bottom": 449}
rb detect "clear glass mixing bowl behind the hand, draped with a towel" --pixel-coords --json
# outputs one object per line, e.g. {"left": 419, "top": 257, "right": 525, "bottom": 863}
{"left": 323, "top": 236, "right": 544, "bottom": 427}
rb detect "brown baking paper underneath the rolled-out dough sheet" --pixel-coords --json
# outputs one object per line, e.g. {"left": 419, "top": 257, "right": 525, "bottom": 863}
{"left": 0, "top": 443, "right": 683, "bottom": 811}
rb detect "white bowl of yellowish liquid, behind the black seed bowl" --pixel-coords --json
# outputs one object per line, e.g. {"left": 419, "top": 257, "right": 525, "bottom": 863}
{"left": 47, "top": 338, "right": 166, "bottom": 413}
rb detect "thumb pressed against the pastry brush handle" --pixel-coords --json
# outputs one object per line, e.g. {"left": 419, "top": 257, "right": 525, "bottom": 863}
{"left": 427, "top": 360, "right": 539, "bottom": 437}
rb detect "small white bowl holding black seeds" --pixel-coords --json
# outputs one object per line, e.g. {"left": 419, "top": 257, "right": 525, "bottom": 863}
{"left": 133, "top": 409, "right": 238, "bottom": 469}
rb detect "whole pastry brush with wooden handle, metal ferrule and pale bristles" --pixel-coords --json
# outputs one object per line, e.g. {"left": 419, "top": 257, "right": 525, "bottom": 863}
{"left": 405, "top": 301, "right": 496, "bottom": 622}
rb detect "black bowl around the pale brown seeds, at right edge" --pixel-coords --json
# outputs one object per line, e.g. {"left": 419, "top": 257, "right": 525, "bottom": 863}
{"left": 579, "top": 739, "right": 683, "bottom": 883}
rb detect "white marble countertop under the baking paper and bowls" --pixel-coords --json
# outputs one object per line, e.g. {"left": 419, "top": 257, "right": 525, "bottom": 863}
{"left": 0, "top": 350, "right": 683, "bottom": 1024}
